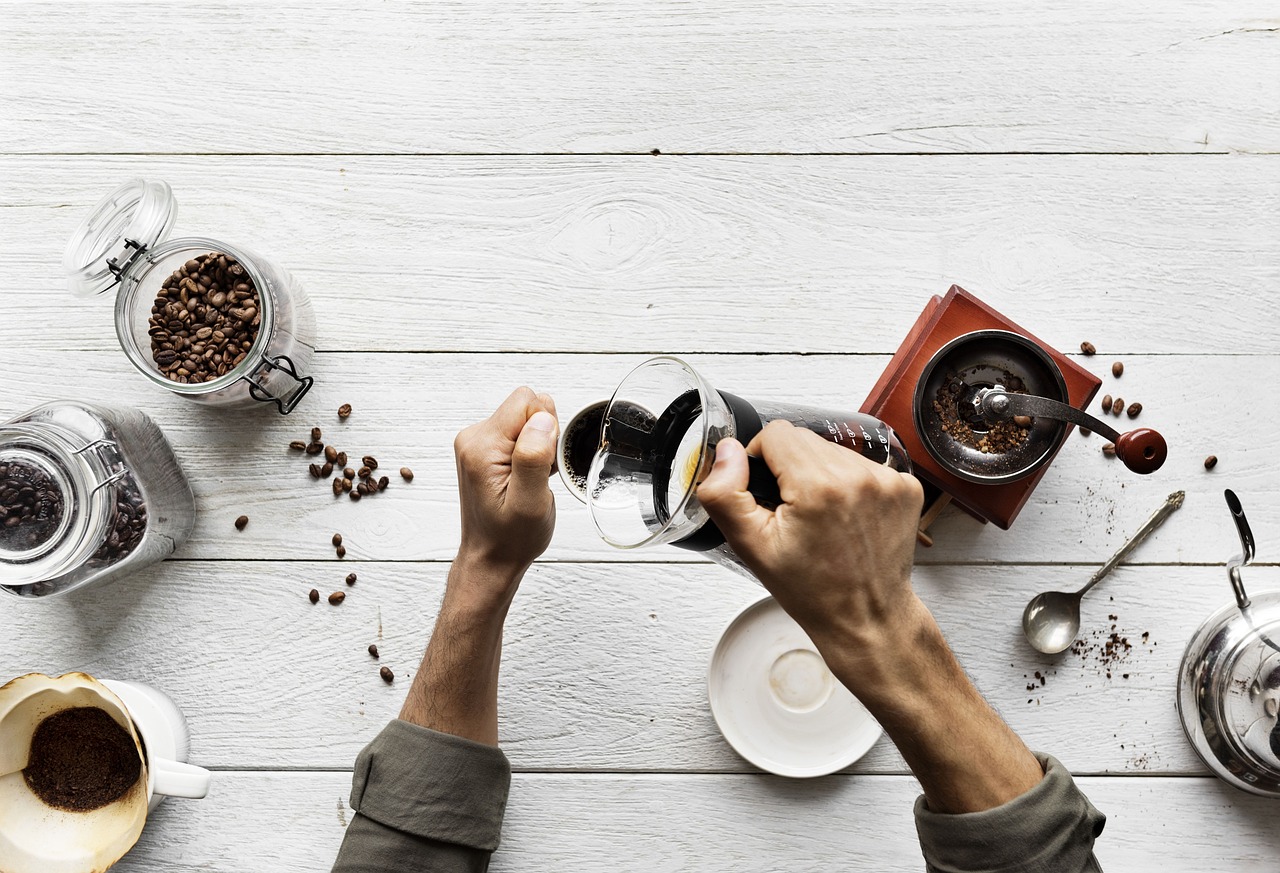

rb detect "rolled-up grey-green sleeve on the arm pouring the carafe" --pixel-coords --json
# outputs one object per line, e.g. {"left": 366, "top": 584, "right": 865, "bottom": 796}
{"left": 915, "top": 753, "right": 1107, "bottom": 873}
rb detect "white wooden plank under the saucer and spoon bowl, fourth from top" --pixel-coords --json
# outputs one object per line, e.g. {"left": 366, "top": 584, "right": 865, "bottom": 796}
{"left": 0, "top": 558, "right": 1280, "bottom": 774}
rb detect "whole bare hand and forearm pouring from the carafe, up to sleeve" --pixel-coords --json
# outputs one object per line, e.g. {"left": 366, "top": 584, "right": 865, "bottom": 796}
{"left": 698, "top": 422, "right": 1043, "bottom": 813}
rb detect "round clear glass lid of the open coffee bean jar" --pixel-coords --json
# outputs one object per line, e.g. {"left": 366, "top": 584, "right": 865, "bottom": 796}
{"left": 63, "top": 179, "right": 178, "bottom": 297}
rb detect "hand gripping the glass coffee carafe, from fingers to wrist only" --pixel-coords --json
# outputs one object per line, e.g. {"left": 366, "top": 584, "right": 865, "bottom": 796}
{"left": 698, "top": 421, "right": 924, "bottom": 670}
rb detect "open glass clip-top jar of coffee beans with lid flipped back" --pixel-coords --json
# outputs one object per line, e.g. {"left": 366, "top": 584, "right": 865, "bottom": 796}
{"left": 63, "top": 179, "right": 315, "bottom": 413}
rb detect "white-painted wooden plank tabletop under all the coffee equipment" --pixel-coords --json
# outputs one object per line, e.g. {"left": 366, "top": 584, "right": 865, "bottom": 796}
{"left": 0, "top": 0, "right": 1280, "bottom": 872}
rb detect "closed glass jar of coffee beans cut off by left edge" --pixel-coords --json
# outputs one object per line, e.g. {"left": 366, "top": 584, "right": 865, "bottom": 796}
{"left": 0, "top": 402, "right": 196, "bottom": 598}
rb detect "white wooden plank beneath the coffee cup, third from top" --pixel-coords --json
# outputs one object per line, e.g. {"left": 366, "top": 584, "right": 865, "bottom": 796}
{"left": 0, "top": 346, "right": 1280, "bottom": 563}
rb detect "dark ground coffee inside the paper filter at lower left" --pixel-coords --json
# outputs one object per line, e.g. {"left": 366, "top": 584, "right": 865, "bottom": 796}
{"left": 22, "top": 707, "right": 142, "bottom": 813}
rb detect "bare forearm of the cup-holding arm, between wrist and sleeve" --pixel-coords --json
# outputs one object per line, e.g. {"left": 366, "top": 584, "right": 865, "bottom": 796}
{"left": 399, "top": 552, "right": 524, "bottom": 746}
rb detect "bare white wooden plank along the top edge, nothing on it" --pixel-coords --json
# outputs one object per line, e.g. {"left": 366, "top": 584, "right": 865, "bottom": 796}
{"left": 0, "top": 0, "right": 1280, "bottom": 154}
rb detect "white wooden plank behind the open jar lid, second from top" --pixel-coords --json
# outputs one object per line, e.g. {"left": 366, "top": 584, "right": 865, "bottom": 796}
{"left": 0, "top": 153, "right": 1280, "bottom": 353}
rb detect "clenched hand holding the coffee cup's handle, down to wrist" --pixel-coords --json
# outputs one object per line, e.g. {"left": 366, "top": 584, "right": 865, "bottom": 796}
{"left": 453, "top": 388, "right": 558, "bottom": 577}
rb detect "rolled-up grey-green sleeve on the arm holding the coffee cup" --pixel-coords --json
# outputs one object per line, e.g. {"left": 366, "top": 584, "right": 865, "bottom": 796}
{"left": 333, "top": 719, "right": 511, "bottom": 873}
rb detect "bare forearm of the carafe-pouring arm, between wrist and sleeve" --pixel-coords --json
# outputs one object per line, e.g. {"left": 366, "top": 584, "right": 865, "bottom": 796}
{"left": 819, "top": 598, "right": 1043, "bottom": 813}
